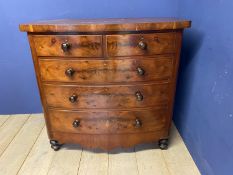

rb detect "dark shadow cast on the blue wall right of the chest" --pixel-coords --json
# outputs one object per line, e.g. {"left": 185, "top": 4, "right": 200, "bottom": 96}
{"left": 174, "top": 29, "right": 204, "bottom": 134}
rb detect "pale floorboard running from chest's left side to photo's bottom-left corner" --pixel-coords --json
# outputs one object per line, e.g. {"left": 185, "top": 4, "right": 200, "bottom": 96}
{"left": 0, "top": 114, "right": 44, "bottom": 175}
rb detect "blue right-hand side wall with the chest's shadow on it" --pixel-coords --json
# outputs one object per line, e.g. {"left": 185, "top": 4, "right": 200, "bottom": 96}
{"left": 174, "top": 0, "right": 233, "bottom": 175}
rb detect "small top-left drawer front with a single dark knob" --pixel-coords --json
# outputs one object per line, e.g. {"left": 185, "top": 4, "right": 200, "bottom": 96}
{"left": 33, "top": 35, "right": 102, "bottom": 57}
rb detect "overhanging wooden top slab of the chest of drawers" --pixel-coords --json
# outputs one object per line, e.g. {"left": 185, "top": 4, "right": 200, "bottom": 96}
{"left": 20, "top": 18, "right": 191, "bottom": 32}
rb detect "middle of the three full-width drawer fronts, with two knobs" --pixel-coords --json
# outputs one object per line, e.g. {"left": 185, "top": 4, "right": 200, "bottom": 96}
{"left": 44, "top": 84, "right": 169, "bottom": 109}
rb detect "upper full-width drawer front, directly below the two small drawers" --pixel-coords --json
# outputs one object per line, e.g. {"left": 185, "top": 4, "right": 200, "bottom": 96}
{"left": 39, "top": 57, "right": 173, "bottom": 83}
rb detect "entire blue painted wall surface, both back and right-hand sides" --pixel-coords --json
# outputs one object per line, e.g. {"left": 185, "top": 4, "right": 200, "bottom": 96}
{"left": 0, "top": 0, "right": 233, "bottom": 175}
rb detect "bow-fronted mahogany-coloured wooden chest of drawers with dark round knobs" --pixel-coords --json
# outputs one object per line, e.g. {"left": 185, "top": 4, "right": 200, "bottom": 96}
{"left": 20, "top": 18, "right": 191, "bottom": 150}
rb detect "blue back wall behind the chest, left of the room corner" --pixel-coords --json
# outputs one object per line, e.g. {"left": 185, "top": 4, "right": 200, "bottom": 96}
{"left": 0, "top": 0, "right": 177, "bottom": 114}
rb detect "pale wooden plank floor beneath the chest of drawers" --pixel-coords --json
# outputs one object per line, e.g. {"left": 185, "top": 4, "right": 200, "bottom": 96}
{"left": 0, "top": 114, "right": 200, "bottom": 175}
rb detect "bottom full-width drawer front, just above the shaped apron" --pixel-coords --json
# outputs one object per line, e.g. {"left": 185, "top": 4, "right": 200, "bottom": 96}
{"left": 49, "top": 109, "right": 167, "bottom": 134}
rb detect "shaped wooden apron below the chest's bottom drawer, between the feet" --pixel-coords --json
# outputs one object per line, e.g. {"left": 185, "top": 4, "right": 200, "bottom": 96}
{"left": 51, "top": 130, "right": 168, "bottom": 151}
